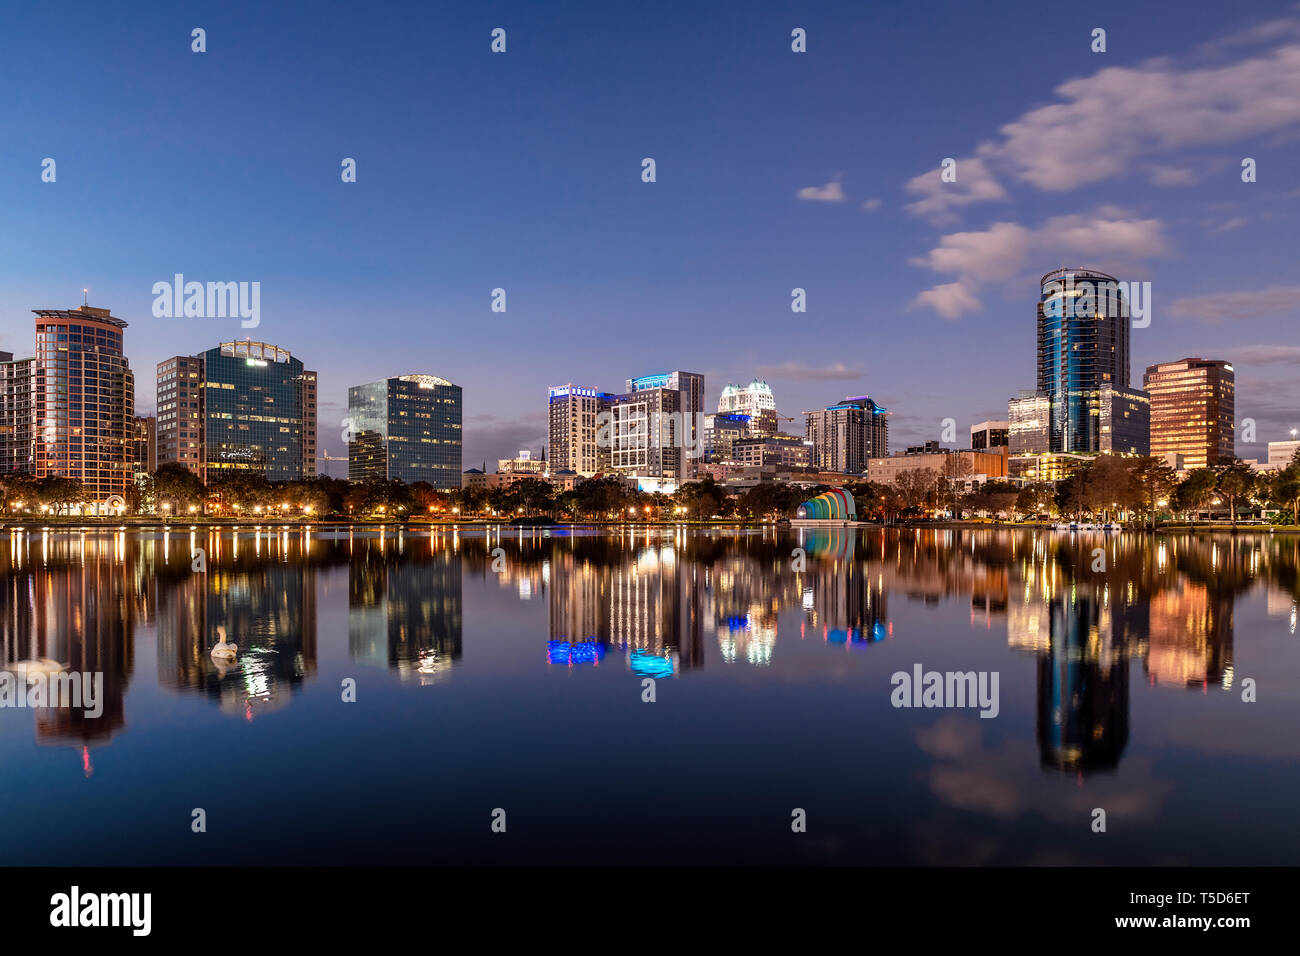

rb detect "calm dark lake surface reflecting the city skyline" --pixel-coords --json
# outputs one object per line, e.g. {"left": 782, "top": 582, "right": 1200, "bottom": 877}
{"left": 0, "top": 528, "right": 1300, "bottom": 865}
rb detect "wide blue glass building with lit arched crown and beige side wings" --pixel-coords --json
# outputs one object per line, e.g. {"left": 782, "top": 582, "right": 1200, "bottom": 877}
{"left": 157, "top": 341, "right": 316, "bottom": 481}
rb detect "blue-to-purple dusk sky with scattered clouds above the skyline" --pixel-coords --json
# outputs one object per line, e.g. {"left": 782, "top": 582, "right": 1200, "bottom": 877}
{"left": 0, "top": 1, "right": 1300, "bottom": 467}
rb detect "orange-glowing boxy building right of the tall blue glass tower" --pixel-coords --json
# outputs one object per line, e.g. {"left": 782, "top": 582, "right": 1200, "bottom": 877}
{"left": 1143, "top": 358, "right": 1236, "bottom": 468}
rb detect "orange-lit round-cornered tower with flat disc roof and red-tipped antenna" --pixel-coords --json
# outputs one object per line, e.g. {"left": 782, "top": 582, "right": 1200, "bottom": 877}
{"left": 33, "top": 306, "right": 135, "bottom": 514}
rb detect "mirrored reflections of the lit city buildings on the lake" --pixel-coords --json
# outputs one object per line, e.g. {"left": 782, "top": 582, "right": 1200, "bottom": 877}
{"left": 0, "top": 528, "right": 1300, "bottom": 790}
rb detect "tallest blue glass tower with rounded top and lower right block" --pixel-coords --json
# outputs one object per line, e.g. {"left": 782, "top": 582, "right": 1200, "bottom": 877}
{"left": 1037, "top": 268, "right": 1149, "bottom": 454}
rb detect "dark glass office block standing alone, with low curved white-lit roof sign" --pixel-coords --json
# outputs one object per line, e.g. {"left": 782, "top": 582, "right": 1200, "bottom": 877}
{"left": 347, "top": 375, "right": 462, "bottom": 490}
